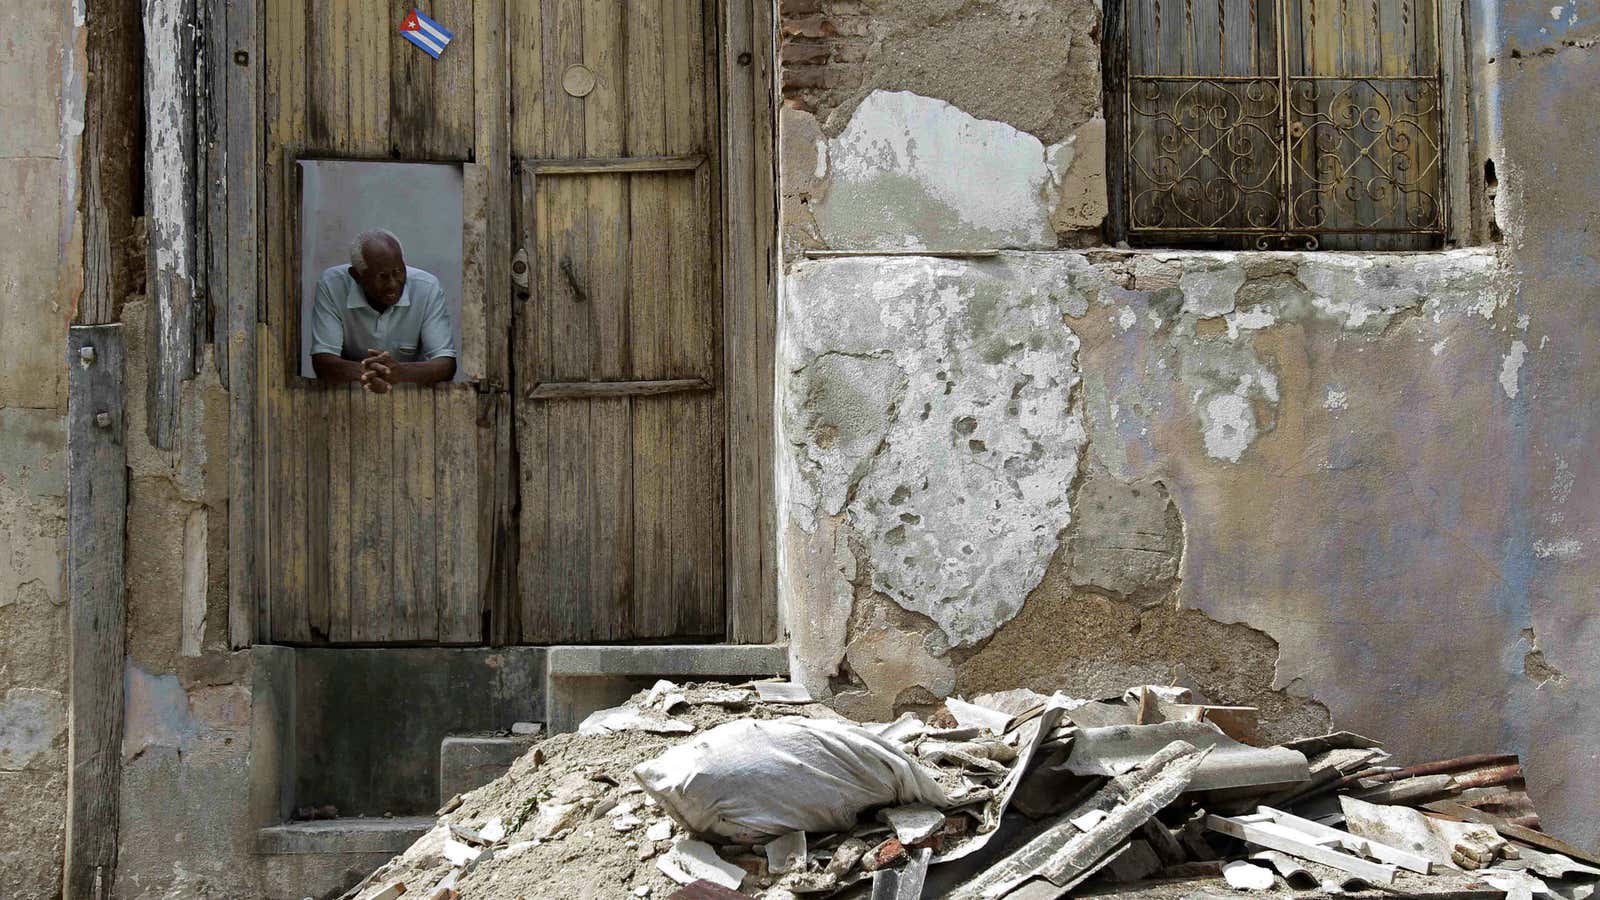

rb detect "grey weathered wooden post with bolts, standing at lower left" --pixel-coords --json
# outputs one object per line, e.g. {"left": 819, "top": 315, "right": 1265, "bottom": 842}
{"left": 62, "top": 325, "right": 128, "bottom": 900}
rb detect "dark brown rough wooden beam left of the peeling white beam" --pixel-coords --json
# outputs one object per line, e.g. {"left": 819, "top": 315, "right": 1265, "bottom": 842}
{"left": 75, "top": 0, "right": 144, "bottom": 325}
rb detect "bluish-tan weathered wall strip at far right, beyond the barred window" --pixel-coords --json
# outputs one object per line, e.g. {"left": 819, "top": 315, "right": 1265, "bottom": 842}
{"left": 1474, "top": 0, "right": 1600, "bottom": 846}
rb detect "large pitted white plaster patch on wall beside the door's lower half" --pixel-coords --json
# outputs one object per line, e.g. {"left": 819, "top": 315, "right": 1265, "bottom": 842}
{"left": 784, "top": 258, "right": 1085, "bottom": 645}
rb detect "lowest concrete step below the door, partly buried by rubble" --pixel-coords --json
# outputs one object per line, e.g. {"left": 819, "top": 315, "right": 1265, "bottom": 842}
{"left": 256, "top": 815, "right": 434, "bottom": 900}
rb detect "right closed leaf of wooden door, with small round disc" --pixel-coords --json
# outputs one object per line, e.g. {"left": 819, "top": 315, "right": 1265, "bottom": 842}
{"left": 510, "top": 0, "right": 726, "bottom": 644}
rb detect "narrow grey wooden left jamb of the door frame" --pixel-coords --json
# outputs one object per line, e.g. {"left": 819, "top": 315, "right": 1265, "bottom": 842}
{"left": 225, "top": 0, "right": 266, "bottom": 650}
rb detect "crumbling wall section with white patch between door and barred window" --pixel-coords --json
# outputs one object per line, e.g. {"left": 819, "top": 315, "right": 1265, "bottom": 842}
{"left": 779, "top": 0, "right": 1106, "bottom": 250}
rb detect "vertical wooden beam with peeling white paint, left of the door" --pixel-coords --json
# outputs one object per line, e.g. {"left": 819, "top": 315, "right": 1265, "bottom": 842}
{"left": 144, "top": 0, "right": 197, "bottom": 450}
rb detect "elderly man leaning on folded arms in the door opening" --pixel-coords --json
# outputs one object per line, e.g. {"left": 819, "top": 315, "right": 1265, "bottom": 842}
{"left": 310, "top": 231, "right": 456, "bottom": 394}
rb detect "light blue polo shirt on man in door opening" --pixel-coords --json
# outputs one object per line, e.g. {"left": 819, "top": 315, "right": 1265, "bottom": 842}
{"left": 310, "top": 263, "right": 456, "bottom": 362}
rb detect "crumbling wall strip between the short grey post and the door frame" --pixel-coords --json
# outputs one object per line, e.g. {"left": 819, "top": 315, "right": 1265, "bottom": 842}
{"left": 115, "top": 298, "right": 257, "bottom": 898}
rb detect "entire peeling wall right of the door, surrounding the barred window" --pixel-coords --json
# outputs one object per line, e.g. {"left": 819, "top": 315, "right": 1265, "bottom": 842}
{"left": 778, "top": 0, "right": 1600, "bottom": 844}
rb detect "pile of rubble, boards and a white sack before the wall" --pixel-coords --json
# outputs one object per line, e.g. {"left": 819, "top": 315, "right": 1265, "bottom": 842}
{"left": 346, "top": 682, "right": 1600, "bottom": 900}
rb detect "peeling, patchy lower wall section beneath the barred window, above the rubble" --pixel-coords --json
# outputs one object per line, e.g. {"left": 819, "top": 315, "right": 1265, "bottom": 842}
{"left": 779, "top": 238, "right": 1555, "bottom": 797}
